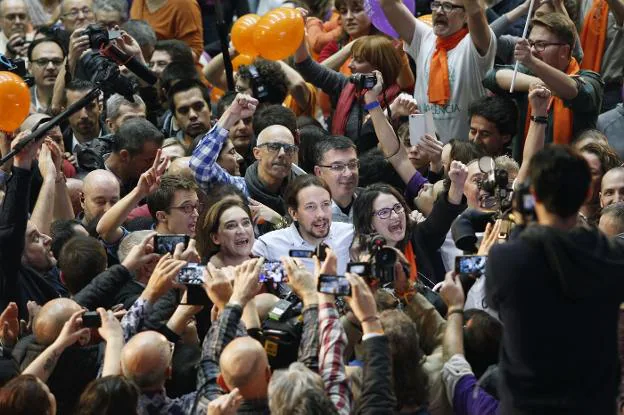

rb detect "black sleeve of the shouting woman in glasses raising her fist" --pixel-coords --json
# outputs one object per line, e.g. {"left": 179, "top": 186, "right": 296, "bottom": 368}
{"left": 409, "top": 192, "right": 466, "bottom": 281}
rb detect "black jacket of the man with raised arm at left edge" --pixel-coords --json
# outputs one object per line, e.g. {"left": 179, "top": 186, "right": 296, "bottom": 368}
{"left": 0, "top": 167, "right": 59, "bottom": 320}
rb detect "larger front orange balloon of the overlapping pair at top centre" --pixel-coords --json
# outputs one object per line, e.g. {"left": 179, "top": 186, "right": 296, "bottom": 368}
{"left": 254, "top": 7, "right": 304, "bottom": 60}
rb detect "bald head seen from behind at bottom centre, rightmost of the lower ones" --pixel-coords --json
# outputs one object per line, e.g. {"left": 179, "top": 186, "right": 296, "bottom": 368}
{"left": 219, "top": 337, "right": 269, "bottom": 398}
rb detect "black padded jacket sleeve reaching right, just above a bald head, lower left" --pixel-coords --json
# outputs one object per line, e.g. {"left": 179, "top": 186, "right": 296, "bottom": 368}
{"left": 74, "top": 265, "right": 132, "bottom": 310}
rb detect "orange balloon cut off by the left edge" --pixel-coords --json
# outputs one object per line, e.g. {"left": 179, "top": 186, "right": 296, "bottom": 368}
{"left": 0, "top": 71, "right": 30, "bottom": 132}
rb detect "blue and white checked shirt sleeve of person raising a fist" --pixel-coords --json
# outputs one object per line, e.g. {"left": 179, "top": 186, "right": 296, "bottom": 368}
{"left": 189, "top": 124, "right": 249, "bottom": 196}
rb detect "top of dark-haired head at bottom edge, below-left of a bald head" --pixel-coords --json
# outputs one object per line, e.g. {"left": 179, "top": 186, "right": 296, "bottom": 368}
{"left": 75, "top": 375, "right": 140, "bottom": 415}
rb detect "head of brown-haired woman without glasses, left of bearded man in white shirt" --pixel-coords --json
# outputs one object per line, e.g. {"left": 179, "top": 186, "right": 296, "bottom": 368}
{"left": 197, "top": 200, "right": 255, "bottom": 268}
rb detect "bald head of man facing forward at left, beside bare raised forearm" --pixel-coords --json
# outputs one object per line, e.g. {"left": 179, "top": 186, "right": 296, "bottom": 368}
{"left": 81, "top": 170, "right": 119, "bottom": 223}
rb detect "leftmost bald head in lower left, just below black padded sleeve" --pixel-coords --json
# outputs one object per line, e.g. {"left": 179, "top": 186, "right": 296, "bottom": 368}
{"left": 33, "top": 298, "right": 82, "bottom": 346}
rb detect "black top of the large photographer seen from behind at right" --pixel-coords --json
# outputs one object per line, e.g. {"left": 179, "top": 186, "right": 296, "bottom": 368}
{"left": 486, "top": 226, "right": 624, "bottom": 414}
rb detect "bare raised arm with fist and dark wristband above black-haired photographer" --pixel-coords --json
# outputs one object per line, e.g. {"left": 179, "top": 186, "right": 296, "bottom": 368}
{"left": 516, "top": 83, "right": 551, "bottom": 183}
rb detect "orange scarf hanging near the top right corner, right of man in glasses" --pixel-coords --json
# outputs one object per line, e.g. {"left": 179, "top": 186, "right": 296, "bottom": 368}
{"left": 581, "top": 0, "right": 609, "bottom": 72}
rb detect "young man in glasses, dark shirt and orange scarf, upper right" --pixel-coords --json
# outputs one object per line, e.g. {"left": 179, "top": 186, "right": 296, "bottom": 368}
{"left": 483, "top": 13, "right": 604, "bottom": 161}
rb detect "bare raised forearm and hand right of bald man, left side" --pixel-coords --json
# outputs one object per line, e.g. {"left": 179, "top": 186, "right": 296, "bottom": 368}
{"left": 96, "top": 149, "right": 167, "bottom": 244}
